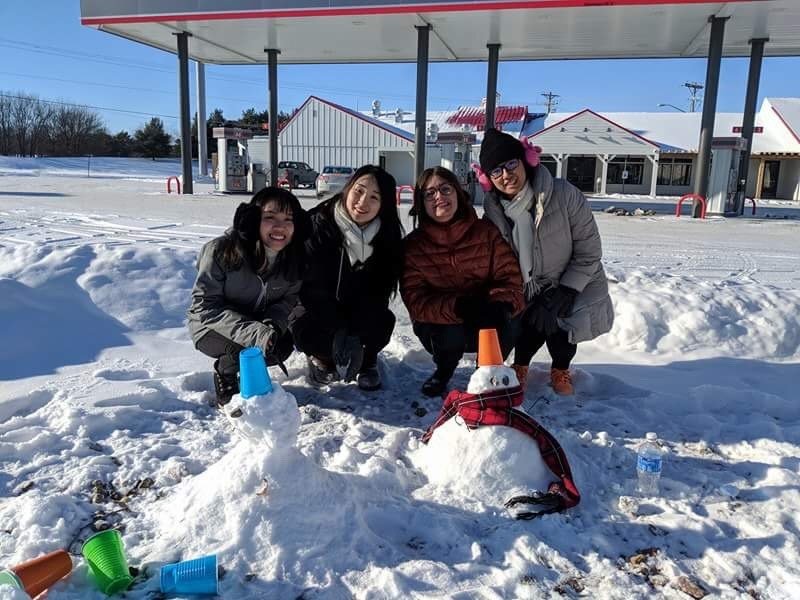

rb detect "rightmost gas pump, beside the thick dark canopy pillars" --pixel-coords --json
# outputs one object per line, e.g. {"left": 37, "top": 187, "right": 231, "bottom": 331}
{"left": 706, "top": 137, "right": 747, "bottom": 217}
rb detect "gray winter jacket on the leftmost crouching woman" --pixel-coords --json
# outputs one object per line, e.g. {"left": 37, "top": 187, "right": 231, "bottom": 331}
{"left": 187, "top": 238, "right": 301, "bottom": 348}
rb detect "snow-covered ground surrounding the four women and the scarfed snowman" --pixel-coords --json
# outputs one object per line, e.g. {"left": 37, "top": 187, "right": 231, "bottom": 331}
{"left": 0, "top": 158, "right": 800, "bottom": 600}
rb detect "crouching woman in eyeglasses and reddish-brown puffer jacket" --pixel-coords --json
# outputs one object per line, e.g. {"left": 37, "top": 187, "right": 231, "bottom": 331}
{"left": 400, "top": 167, "right": 525, "bottom": 396}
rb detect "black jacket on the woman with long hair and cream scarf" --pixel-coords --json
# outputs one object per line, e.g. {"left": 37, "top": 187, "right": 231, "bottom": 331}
{"left": 300, "top": 196, "right": 402, "bottom": 331}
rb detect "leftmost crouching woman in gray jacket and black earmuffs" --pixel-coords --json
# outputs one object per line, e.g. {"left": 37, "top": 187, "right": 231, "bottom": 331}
{"left": 188, "top": 187, "right": 309, "bottom": 405}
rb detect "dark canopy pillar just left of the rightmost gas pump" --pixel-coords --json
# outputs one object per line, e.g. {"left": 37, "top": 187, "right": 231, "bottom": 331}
{"left": 692, "top": 17, "right": 728, "bottom": 219}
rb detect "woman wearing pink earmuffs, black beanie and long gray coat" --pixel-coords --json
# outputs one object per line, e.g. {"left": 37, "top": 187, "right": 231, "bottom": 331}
{"left": 473, "top": 129, "right": 614, "bottom": 395}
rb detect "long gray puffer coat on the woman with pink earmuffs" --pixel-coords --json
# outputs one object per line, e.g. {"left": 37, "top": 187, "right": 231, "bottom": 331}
{"left": 483, "top": 167, "right": 614, "bottom": 344}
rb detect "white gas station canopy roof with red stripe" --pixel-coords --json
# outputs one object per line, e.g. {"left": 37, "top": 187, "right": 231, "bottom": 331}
{"left": 81, "top": 0, "right": 800, "bottom": 64}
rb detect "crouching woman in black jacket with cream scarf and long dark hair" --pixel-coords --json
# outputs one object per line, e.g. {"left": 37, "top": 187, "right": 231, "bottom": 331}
{"left": 292, "top": 165, "right": 403, "bottom": 391}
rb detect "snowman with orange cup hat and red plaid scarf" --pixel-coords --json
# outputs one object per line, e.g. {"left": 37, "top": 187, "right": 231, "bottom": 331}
{"left": 415, "top": 329, "right": 580, "bottom": 519}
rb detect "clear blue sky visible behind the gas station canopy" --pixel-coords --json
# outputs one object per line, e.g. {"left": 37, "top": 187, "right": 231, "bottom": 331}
{"left": 0, "top": 0, "right": 800, "bottom": 133}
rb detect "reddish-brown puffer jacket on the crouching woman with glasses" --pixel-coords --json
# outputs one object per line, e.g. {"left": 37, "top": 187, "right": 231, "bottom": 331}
{"left": 400, "top": 206, "right": 525, "bottom": 325}
